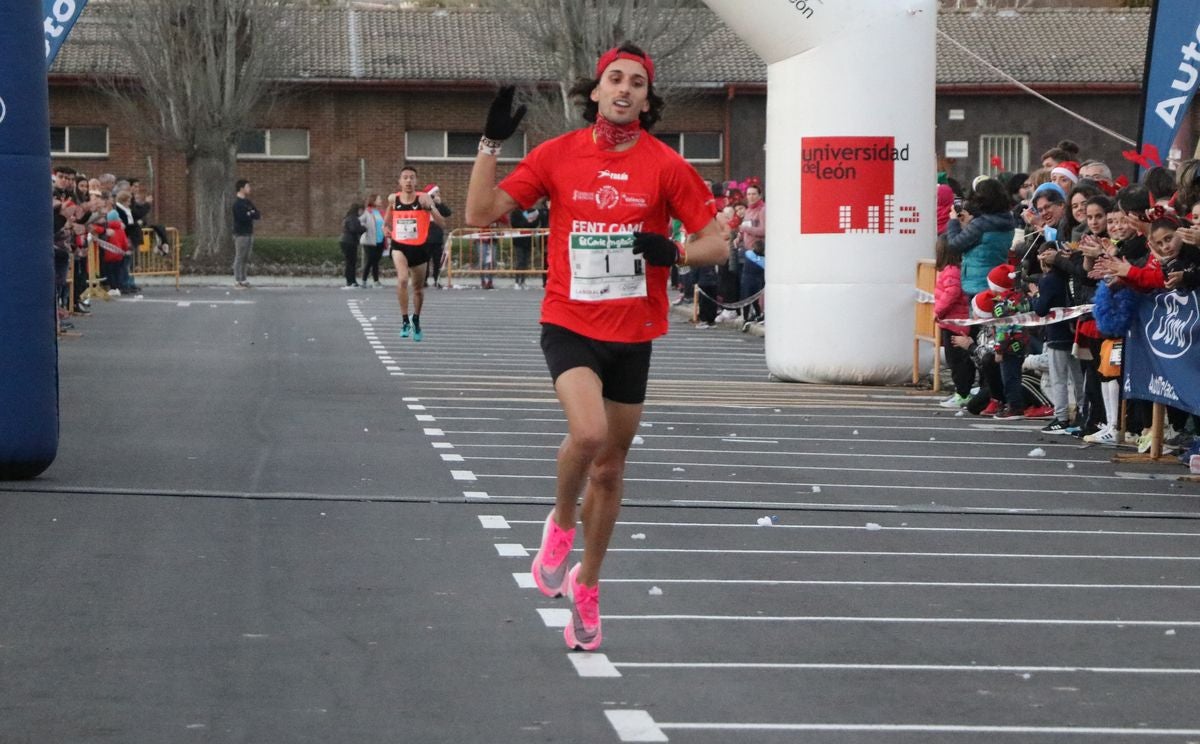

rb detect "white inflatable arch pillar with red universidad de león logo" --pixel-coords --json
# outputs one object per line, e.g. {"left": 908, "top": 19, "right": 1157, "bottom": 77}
{"left": 704, "top": 0, "right": 937, "bottom": 383}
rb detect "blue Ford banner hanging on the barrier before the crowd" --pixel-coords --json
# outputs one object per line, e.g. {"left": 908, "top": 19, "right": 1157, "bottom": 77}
{"left": 1124, "top": 292, "right": 1200, "bottom": 415}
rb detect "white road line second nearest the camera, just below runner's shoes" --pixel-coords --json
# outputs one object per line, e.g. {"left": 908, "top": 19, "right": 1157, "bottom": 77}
{"left": 609, "top": 667, "right": 1200, "bottom": 677}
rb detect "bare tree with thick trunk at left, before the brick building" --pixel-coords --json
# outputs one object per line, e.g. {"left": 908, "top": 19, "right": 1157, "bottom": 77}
{"left": 96, "top": 0, "right": 289, "bottom": 258}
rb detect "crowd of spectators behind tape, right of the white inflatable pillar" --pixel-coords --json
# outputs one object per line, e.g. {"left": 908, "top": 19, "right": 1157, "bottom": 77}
{"left": 934, "top": 142, "right": 1200, "bottom": 465}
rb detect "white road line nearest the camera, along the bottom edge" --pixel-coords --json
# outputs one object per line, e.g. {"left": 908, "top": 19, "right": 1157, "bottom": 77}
{"left": 652, "top": 710, "right": 1200, "bottom": 742}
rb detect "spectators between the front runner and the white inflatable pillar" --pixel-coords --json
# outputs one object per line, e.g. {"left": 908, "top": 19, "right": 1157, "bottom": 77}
{"left": 672, "top": 178, "right": 767, "bottom": 331}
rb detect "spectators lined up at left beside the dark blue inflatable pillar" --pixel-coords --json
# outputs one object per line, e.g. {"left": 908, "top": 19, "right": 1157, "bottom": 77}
{"left": 50, "top": 166, "right": 170, "bottom": 328}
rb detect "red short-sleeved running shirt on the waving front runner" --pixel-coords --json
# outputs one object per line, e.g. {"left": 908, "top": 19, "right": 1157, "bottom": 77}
{"left": 500, "top": 127, "right": 716, "bottom": 343}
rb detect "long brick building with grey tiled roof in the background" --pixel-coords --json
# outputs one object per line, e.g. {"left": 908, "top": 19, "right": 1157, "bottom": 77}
{"left": 49, "top": 5, "right": 1200, "bottom": 235}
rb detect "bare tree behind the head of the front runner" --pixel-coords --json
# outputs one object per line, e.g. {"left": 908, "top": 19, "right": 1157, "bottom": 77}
{"left": 480, "top": 0, "right": 716, "bottom": 136}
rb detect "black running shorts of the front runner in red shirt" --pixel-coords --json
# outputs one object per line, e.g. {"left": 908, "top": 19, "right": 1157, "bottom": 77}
{"left": 541, "top": 323, "right": 650, "bottom": 406}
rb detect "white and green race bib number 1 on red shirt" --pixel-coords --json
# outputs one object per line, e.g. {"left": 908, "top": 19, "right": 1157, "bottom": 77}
{"left": 569, "top": 233, "right": 646, "bottom": 302}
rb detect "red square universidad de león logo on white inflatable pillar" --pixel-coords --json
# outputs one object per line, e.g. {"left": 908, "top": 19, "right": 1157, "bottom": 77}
{"left": 800, "top": 137, "right": 908, "bottom": 234}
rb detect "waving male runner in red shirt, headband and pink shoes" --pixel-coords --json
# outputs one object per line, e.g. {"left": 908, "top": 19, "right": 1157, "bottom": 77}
{"left": 467, "top": 43, "right": 728, "bottom": 650}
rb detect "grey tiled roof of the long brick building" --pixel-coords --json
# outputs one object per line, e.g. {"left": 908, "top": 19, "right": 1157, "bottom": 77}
{"left": 50, "top": 4, "right": 1150, "bottom": 85}
